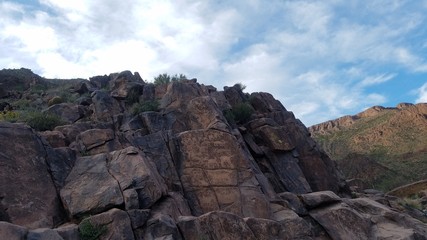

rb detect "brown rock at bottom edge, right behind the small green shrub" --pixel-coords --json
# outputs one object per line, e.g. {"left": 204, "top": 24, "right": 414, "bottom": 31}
{"left": 79, "top": 208, "right": 134, "bottom": 240}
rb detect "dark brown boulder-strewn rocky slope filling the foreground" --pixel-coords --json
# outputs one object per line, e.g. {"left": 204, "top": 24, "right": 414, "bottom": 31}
{"left": 0, "top": 69, "right": 427, "bottom": 239}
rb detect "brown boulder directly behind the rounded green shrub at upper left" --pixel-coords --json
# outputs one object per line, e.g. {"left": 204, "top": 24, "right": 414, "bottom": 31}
{"left": 45, "top": 103, "right": 87, "bottom": 123}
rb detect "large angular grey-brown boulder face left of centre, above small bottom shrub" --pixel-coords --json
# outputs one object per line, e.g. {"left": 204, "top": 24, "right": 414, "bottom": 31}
{"left": 61, "top": 154, "right": 123, "bottom": 216}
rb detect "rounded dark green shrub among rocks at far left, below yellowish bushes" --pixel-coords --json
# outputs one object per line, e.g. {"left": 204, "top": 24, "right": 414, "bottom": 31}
{"left": 25, "top": 112, "right": 62, "bottom": 131}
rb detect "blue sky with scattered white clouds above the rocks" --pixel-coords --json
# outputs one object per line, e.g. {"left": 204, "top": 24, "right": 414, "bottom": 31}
{"left": 0, "top": 0, "right": 427, "bottom": 126}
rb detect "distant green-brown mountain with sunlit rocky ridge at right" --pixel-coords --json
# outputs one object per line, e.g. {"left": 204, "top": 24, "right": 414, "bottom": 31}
{"left": 309, "top": 103, "right": 427, "bottom": 190}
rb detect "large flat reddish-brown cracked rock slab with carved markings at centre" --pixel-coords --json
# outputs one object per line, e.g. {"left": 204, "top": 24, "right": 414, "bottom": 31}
{"left": 177, "top": 130, "right": 270, "bottom": 218}
